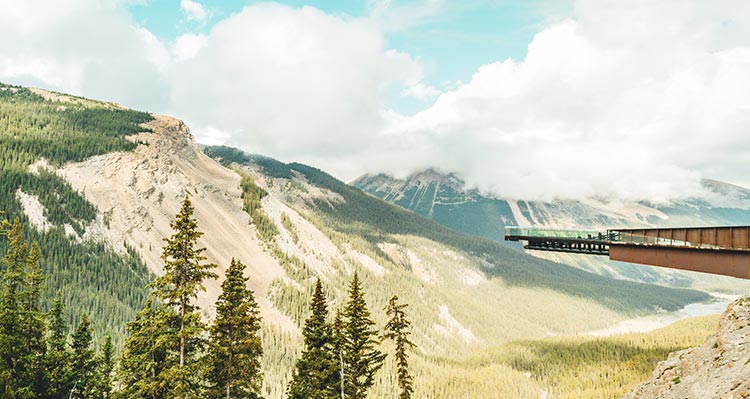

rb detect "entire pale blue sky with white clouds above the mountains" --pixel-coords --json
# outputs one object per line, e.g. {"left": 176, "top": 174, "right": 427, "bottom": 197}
{"left": 0, "top": 0, "right": 750, "bottom": 202}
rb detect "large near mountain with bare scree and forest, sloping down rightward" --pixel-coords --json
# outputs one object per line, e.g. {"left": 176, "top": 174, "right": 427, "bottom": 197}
{"left": 0, "top": 85, "right": 708, "bottom": 398}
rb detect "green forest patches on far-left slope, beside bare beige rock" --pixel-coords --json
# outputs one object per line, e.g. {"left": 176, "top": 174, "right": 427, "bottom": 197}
{"left": 0, "top": 83, "right": 152, "bottom": 341}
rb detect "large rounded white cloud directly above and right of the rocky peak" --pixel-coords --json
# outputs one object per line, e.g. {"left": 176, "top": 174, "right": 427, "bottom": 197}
{"left": 169, "top": 4, "right": 422, "bottom": 169}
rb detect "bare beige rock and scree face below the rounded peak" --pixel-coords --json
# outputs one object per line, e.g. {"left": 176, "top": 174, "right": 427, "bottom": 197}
{"left": 58, "top": 115, "right": 297, "bottom": 331}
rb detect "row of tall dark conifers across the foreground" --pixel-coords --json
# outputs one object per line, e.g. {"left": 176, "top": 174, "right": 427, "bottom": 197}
{"left": 0, "top": 197, "right": 414, "bottom": 399}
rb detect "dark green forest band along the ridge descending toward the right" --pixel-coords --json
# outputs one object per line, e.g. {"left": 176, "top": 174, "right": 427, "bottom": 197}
{"left": 205, "top": 147, "right": 709, "bottom": 314}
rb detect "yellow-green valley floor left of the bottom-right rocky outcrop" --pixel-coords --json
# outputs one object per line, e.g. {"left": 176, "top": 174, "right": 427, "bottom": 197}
{"left": 419, "top": 315, "right": 719, "bottom": 399}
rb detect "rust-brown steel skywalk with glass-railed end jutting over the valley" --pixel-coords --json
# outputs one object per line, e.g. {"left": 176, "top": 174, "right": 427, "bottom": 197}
{"left": 505, "top": 226, "right": 750, "bottom": 278}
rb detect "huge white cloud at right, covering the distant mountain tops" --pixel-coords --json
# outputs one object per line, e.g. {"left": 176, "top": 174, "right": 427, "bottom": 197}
{"left": 374, "top": 1, "right": 750, "bottom": 200}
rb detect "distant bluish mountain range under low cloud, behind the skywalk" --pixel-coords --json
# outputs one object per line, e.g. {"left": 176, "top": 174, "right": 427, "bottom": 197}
{"left": 351, "top": 169, "right": 750, "bottom": 292}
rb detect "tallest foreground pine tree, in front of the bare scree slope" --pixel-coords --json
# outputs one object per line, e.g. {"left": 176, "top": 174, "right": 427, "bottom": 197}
{"left": 153, "top": 196, "right": 218, "bottom": 399}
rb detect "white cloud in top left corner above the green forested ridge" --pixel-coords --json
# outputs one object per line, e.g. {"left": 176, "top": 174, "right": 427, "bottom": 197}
{"left": 0, "top": 0, "right": 169, "bottom": 110}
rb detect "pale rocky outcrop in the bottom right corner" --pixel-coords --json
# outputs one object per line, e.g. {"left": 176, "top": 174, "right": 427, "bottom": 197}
{"left": 623, "top": 297, "right": 750, "bottom": 399}
